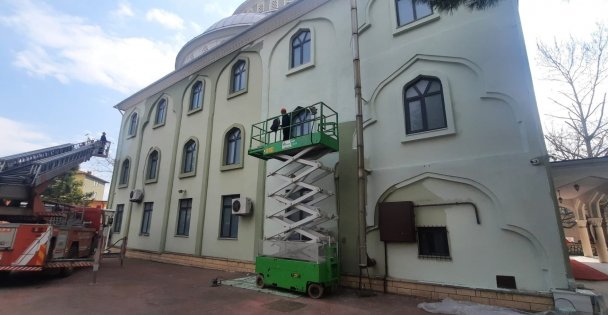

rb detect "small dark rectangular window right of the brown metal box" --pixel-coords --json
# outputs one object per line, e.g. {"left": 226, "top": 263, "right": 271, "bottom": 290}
{"left": 416, "top": 226, "right": 452, "bottom": 260}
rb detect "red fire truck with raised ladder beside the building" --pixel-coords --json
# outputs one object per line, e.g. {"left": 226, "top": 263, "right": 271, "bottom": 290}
{"left": 0, "top": 141, "right": 109, "bottom": 273}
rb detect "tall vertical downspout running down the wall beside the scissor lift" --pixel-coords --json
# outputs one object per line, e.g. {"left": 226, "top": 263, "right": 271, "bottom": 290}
{"left": 350, "top": 0, "right": 367, "bottom": 268}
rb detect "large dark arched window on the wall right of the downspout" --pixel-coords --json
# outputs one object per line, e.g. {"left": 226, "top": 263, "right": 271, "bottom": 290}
{"left": 404, "top": 77, "right": 447, "bottom": 134}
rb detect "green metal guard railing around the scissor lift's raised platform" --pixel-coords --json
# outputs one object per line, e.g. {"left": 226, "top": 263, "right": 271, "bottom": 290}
{"left": 249, "top": 102, "right": 338, "bottom": 149}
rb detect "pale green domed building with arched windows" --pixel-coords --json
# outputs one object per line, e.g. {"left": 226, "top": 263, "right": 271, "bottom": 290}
{"left": 110, "top": 0, "right": 571, "bottom": 308}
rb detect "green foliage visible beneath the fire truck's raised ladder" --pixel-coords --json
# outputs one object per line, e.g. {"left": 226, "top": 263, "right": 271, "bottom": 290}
{"left": 42, "top": 171, "right": 93, "bottom": 206}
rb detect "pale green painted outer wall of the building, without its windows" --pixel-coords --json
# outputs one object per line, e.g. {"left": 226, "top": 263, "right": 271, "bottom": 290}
{"left": 112, "top": 0, "right": 568, "bottom": 291}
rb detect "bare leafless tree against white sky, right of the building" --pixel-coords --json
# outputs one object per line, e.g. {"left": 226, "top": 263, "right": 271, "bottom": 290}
{"left": 537, "top": 24, "right": 608, "bottom": 160}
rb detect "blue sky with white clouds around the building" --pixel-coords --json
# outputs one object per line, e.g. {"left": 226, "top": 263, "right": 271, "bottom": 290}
{"left": 0, "top": 0, "right": 608, "bottom": 188}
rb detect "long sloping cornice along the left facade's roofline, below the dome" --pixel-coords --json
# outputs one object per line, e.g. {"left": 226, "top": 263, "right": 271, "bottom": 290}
{"left": 114, "top": 0, "right": 330, "bottom": 111}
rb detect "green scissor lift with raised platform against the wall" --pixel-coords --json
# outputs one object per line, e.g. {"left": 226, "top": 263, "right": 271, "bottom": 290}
{"left": 248, "top": 103, "right": 340, "bottom": 298}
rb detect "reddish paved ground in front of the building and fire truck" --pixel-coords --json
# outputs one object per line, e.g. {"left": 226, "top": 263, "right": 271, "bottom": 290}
{"left": 0, "top": 259, "right": 436, "bottom": 315}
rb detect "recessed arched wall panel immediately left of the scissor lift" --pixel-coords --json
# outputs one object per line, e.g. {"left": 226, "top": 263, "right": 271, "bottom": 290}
{"left": 202, "top": 52, "right": 263, "bottom": 261}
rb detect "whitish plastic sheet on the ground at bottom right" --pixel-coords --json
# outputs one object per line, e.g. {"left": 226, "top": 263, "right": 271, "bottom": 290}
{"left": 418, "top": 298, "right": 529, "bottom": 315}
